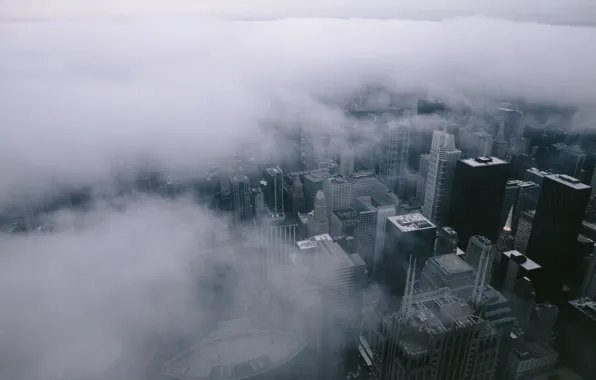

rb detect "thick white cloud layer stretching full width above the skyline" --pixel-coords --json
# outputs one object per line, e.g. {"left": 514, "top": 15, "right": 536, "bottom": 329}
{"left": 0, "top": 16, "right": 596, "bottom": 205}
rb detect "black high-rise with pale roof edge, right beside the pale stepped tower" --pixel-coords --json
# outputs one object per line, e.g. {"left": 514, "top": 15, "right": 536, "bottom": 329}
{"left": 447, "top": 157, "right": 509, "bottom": 249}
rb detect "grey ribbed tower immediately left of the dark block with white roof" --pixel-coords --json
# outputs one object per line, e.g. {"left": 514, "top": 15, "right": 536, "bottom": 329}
{"left": 353, "top": 191, "right": 396, "bottom": 273}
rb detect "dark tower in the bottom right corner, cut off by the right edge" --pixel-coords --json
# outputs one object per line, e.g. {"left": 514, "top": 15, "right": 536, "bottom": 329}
{"left": 558, "top": 298, "right": 596, "bottom": 379}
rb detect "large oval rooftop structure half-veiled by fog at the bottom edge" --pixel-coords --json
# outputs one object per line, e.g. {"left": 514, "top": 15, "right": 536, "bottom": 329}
{"left": 165, "top": 330, "right": 306, "bottom": 380}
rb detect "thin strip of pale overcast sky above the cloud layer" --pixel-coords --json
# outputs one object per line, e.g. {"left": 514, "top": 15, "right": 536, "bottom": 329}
{"left": 0, "top": 0, "right": 596, "bottom": 23}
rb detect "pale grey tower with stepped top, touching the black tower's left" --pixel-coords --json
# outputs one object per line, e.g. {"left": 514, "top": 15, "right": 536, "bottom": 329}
{"left": 422, "top": 131, "right": 461, "bottom": 227}
